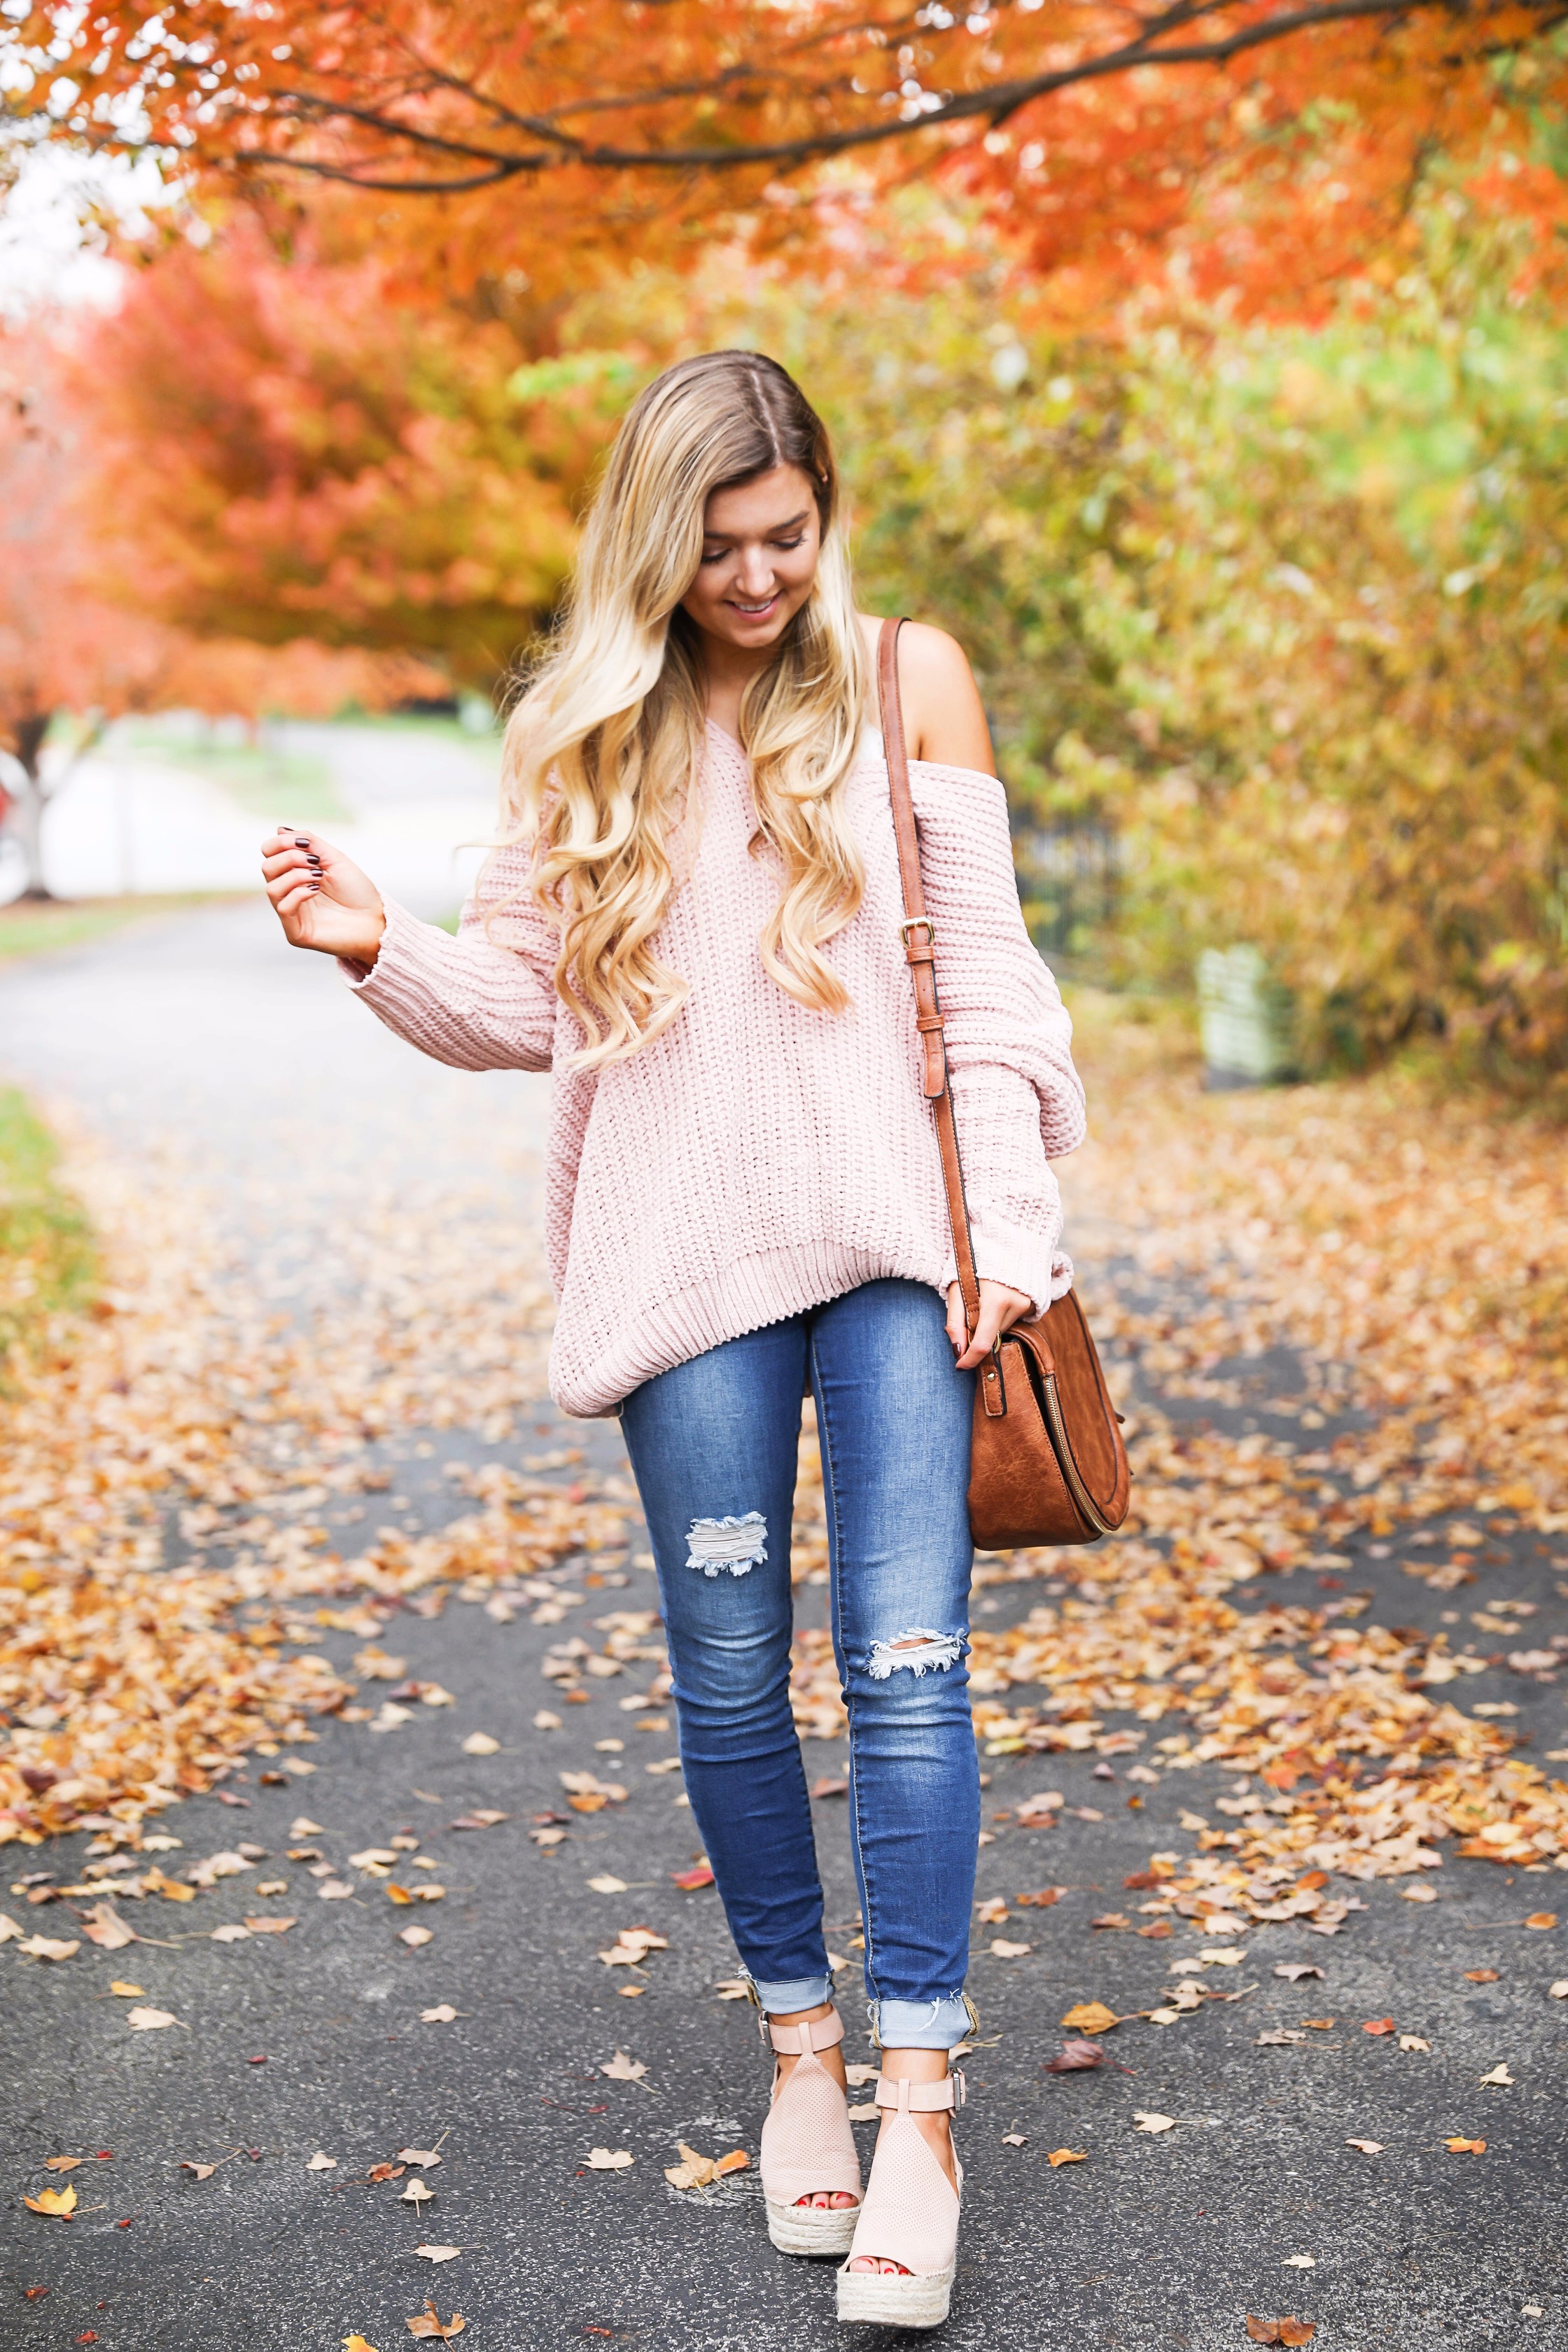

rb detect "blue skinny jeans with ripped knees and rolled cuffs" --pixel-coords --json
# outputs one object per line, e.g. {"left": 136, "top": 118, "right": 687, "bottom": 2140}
{"left": 621, "top": 1282, "right": 980, "bottom": 2049}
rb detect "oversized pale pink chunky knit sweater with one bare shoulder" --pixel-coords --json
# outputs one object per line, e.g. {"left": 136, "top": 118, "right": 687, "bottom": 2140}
{"left": 346, "top": 727, "right": 1084, "bottom": 1418}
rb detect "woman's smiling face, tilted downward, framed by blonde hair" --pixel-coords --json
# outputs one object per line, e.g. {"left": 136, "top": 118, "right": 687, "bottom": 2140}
{"left": 682, "top": 465, "right": 822, "bottom": 652}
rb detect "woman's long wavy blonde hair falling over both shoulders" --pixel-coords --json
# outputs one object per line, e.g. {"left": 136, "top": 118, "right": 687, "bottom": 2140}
{"left": 491, "top": 351, "right": 870, "bottom": 1068}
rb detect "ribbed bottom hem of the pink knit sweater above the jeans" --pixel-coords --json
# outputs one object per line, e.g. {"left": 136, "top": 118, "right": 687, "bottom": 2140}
{"left": 550, "top": 1240, "right": 943, "bottom": 1420}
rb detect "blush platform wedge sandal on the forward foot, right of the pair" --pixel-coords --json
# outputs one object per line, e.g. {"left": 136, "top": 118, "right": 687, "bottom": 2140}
{"left": 839, "top": 2075, "right": 964, "bottom": 2328}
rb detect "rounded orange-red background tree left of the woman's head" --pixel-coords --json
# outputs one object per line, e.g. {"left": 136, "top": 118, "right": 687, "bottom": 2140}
{"left": 78, "top": 218, "right": 630, "bottom": 687}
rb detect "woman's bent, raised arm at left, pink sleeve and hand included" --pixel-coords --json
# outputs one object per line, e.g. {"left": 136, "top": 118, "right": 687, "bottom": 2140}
{"left": 261, "top": 825, "right": 557, "bottom": 1070}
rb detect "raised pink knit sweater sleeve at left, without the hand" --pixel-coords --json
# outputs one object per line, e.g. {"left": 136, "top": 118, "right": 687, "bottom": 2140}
{"left": 339, "top": 847, "right": 559, "bottom": 1070}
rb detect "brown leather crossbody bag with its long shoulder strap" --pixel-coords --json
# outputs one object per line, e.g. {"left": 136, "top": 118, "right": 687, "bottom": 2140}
{"left": 877, "top": 621, "right": 1130, "bottom": 1553}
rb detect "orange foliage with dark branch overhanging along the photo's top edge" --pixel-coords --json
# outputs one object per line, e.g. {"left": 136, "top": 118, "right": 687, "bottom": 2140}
{"left": 0, "top": 0, "right": 1568, "bottom": 303}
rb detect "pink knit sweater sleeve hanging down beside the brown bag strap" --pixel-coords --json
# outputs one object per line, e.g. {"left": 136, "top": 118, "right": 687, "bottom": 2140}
{"left": 910, "top": 762, "right": 1086, "bottom": 1312}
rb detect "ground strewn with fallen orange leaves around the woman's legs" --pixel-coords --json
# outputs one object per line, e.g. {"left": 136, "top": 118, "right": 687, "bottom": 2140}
{"left": 0, "top": 917, "right": 1568, "bottom": 2352}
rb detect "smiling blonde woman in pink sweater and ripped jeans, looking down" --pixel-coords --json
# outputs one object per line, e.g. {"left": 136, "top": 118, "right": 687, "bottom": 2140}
{"left": 263, "top": 351, "right": 1084, "bottom": 2326}
